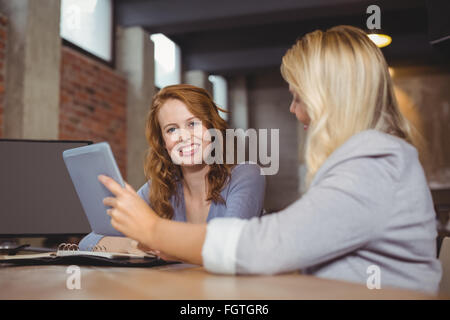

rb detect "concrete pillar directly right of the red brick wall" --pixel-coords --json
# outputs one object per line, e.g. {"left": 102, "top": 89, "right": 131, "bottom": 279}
{"left": 116, "top": 27, "right": 155, "bottom": 188}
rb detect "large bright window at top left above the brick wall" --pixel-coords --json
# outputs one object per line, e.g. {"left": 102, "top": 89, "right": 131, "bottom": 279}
{"left": 60, "top": 0, "right": 114, "bottom": 63}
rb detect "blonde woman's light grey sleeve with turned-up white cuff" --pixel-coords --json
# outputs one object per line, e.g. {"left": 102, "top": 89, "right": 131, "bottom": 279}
{"left": 203, "top": 158, "right": 394, "bottom": 274}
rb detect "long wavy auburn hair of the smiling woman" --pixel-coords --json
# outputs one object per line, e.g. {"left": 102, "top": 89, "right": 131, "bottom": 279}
{"left": 144, "top": 84, "right": 234, "bottom": 219}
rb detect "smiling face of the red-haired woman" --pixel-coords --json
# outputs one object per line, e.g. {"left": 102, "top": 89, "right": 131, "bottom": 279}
{"left": 158, "top": 99, "right": 211, "bottom": 166}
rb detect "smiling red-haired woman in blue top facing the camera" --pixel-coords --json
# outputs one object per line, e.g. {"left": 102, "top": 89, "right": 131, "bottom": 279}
{"left": 80, "top": 84, "right": 265, "bottom": 257}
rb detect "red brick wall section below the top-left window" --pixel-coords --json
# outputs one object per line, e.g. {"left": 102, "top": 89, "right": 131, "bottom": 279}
{"left": 59, "top": 46, "right": 127, "bottom": 177}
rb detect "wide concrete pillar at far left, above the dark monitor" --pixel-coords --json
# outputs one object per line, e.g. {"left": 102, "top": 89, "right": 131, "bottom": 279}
{"left": 0, "top": 0, "right": 61, "bottom": 139}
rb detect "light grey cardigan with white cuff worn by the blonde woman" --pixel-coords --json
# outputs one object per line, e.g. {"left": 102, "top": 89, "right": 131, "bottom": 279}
{"left": 202, "top": 130, "right": 442, "bottom": 293}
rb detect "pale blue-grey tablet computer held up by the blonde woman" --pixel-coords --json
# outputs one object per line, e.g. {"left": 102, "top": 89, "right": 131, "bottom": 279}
{"left": 63, "top": 142, "right": 125, "bottom": 236}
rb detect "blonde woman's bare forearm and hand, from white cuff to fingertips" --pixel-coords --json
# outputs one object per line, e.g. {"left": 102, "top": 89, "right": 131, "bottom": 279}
{"left": 99, "top": 176, "right": 206, "bottom": 264}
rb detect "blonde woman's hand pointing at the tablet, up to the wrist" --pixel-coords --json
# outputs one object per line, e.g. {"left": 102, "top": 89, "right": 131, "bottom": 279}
{"left": 98, "top": 175, "right": 160, "bottom": 247}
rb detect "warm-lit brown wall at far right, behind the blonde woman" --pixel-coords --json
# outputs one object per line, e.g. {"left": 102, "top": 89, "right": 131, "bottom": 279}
{"left": 393, "top": 66, "right": 450, "bottom": 189}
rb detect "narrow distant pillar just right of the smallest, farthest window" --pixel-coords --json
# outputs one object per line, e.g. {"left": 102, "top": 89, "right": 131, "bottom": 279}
{"left": 228, "top": 76, "right": 248, "bottom": 130}
